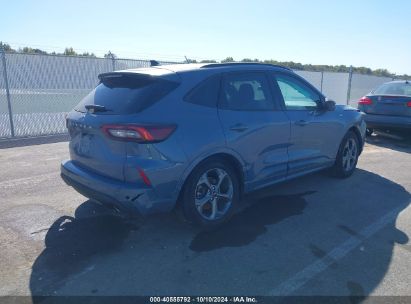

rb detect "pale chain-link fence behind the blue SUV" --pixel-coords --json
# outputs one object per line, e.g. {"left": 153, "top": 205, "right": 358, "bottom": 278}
{"left": 0, "top": 52, "right": 400, "bottom": 138}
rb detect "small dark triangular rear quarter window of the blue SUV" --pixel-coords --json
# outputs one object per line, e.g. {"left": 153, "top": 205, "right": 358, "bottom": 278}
{"left": 184, "top": 76, "right": 220, "bottom": 107}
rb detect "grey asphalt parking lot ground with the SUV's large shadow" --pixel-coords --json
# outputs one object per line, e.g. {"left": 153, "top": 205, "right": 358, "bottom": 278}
{"left": 0, "top": 135, "right": 411, "bottom": 302}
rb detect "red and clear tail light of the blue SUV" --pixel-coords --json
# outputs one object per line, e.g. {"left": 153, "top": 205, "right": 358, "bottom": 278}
{"left": 101, "top": 125, "right": 176, "bottom": 143}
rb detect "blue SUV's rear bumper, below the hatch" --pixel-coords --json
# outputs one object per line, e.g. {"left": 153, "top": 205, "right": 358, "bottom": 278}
{"left": 60, "top": 160, "right": 175, "bottom": 215}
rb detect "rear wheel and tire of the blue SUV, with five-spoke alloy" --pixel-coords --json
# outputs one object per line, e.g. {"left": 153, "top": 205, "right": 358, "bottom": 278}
{"left": 181, "top": 160, "right": 240, "bottom": 229}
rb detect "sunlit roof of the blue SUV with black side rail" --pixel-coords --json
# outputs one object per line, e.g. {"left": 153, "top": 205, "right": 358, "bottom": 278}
{"left": 116, "top": 62, "right": 292, "bottom": 76}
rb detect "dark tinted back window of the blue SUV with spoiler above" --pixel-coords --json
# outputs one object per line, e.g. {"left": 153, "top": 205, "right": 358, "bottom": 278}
{"left": 74, "top": 74, "right": 178, "bottom": 115}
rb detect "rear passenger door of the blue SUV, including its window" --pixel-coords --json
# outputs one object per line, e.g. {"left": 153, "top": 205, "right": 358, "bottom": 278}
{"left": 218, "top": 71, "right": 290, "bottom": 190}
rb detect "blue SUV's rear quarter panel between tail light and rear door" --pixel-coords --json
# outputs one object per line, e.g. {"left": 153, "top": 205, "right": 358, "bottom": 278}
{"left": 135, "top": 71, "right": 232, "bottom": 199}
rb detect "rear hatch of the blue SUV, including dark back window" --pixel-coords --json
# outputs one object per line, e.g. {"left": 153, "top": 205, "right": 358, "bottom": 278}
{"left": 67, "top": 71, "right": 179, "bottom": 181}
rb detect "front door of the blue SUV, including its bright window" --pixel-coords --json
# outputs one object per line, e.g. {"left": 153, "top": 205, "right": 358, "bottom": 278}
{"left": 271, "top": 73, "right": 344, "bottom": 177}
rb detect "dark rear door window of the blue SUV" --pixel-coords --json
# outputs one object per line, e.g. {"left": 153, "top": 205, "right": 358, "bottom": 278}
{"left": 220, "top": 72, "right": 274, "bottom": 111}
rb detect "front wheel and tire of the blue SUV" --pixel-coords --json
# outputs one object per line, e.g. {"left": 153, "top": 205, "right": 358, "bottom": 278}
{"left": 332, "top": 131, "right": 360, "bottom": 178}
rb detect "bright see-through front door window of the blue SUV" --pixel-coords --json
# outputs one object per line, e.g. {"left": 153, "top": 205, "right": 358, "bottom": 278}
{"left": 275, "top": 75, "right": 321, "bottom": 110}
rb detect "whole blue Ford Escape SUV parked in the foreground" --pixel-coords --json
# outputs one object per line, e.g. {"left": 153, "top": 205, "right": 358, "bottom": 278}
{"left": 61, "top": 63, "right": 366, "bottom": 227}
